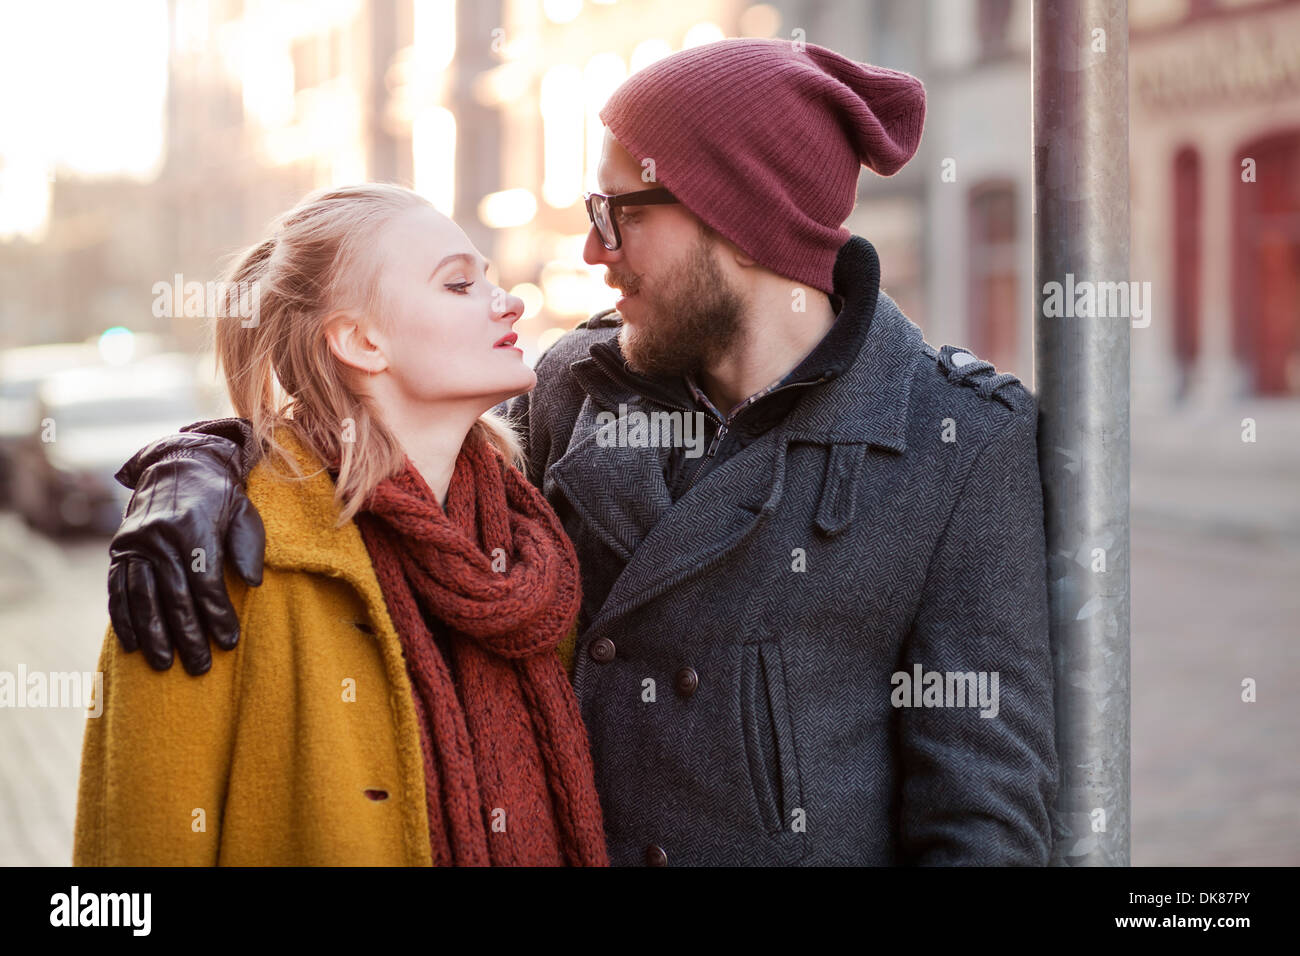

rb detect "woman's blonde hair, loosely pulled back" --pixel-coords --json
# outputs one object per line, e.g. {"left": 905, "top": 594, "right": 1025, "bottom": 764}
{"left": 213, "top": 183, "right": 523, "bottom": 525}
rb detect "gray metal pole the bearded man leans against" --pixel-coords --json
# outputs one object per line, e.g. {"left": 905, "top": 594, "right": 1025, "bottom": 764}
{"left": 1032, "top": 0, "right": 1130, "bottom": 866}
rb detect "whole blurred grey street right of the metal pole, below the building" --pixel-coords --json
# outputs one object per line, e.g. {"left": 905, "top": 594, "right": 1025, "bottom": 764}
{"left": 1131, "top": 395, "right": 1300, "bottom": 866}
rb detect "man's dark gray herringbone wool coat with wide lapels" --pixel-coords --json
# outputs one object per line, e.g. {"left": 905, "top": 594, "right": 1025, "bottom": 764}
{"left": 511, "top": 237, "right": 1057, "bottom": 865}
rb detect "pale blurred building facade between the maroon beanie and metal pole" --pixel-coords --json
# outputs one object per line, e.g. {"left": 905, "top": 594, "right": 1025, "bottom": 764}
{"left": 920, "top": 0, "right": 1035, "bottom": 382}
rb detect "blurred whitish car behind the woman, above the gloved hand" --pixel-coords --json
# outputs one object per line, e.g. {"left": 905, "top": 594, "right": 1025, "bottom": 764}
{"left": 12, "top": 352, "right": 208, "bottom": 535}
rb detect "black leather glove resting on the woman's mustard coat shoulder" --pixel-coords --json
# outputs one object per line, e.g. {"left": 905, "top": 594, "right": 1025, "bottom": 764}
{"left": 108, "top": 419, "right": 267, "bottom": 675}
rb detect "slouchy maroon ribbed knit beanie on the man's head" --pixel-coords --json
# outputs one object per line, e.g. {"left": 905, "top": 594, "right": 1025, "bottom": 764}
{"left": 601, "top": 39, "right": 926, "bottom": 293}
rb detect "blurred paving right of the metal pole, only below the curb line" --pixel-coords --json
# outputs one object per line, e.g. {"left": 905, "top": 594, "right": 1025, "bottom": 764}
{"left": 1131, "top": 522, "right": 1300, "bottom": 866}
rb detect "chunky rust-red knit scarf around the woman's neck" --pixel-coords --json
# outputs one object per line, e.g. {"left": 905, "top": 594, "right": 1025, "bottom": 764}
{"left": 358, "top": 429, "right": 608, "bottom": 866}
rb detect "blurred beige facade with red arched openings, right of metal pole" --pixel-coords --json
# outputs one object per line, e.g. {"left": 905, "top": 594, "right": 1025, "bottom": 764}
{"left": 1130, "top": 0, "right": 1300, "bottom": 403}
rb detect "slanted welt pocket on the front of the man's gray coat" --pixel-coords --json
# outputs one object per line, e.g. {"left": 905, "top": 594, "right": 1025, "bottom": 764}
{"left": 740, "top": 644, "right": 801, "bottom": 835}
